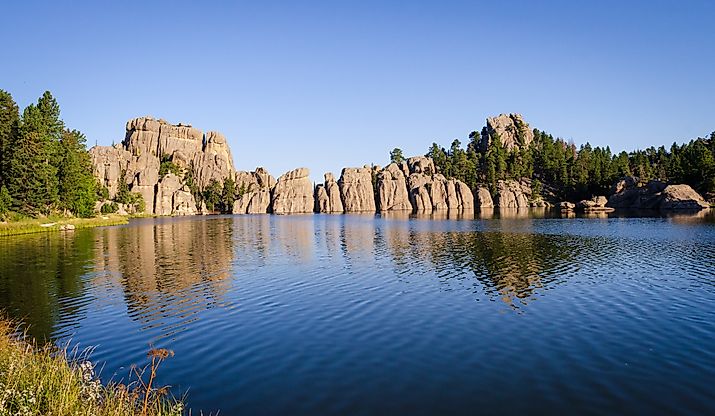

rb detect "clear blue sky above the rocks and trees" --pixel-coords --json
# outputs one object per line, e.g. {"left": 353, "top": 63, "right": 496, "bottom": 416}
{"left": 0, "top": 0, "right": 715, "bottom": 179}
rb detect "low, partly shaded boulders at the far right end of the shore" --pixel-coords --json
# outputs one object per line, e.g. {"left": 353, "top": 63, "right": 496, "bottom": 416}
{"left": 607, "top": 176, "right": 709, "bottom": 210}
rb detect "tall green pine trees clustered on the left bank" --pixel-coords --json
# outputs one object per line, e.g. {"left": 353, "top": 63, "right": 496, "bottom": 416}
{"left": 0, "top": 90, "right": 101, "bottom": 219}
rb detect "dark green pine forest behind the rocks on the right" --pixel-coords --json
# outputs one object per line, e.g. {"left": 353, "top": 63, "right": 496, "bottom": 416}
{"left": 390, "top": 129, "right": 715, "bottom": 200}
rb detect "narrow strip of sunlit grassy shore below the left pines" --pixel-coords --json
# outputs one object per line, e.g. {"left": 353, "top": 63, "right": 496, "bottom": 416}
{"left": 0, "top": 214, "right": 128, "bottom": 236}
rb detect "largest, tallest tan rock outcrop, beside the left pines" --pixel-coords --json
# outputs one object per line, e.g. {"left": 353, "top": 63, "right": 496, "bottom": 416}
{"left": 89, "top": 117, "right": 235, "bottom": 215}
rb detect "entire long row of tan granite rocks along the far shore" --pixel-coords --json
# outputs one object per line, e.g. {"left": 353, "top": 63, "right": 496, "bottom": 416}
{"left": 89, "top": 116, "right": 709, "bottom": 216}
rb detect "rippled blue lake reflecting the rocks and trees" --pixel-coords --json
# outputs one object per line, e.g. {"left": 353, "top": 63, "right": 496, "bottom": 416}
{"left": 0, "top": 210, "right": 715, "bottom": 415}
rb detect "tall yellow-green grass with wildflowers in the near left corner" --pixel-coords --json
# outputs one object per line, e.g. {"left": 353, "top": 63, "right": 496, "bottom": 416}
{"left": 0, "top": 318, "right": 184, "bottom": 416}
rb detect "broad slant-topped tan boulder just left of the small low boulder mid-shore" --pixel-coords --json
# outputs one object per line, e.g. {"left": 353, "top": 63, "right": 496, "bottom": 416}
{"left": 271, "top": 168, "right": 315, "bottom": 214}
